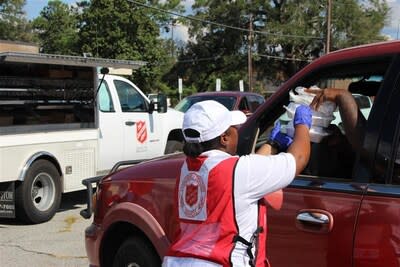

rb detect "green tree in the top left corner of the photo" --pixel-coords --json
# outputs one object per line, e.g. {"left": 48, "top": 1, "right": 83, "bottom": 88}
{"left": 0, "top": 0, "right": 33, "bottom": 42}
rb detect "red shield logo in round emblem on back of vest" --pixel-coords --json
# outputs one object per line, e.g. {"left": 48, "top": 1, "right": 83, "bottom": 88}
{"left": 179, "top": 172, "right": 207, "bottom": 219}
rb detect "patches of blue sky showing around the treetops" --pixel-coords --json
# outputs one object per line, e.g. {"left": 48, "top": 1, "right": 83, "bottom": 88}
{"left": 25, "top": 0, "right": 400, "bottom": 39}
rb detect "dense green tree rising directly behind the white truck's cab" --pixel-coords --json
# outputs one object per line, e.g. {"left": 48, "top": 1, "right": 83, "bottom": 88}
{"left": 78, "top": 0, "right": 177, "bottom": 92}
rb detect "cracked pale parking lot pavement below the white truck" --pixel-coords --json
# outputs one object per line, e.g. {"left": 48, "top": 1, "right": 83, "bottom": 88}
{"left": 0, "top": 191, "right": 91, "bottom": 267}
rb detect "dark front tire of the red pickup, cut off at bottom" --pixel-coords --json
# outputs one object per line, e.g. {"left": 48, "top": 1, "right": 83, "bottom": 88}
{"left": 113, "top": 236, "right": 161, "bottom": 267}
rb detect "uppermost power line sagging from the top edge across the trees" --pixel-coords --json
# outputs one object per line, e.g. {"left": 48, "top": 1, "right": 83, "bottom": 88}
{"left": 127, "top": 0, "right": 323, "bottom": 40}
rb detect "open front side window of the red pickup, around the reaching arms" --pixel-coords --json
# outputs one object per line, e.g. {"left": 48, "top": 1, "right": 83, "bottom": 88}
{"left": 255, "top": 60, "right": 390, "bottom": 180}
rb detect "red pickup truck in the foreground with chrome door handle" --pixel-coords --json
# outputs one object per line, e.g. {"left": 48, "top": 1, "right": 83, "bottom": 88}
{"left": 82, "top": 41, "right": 400, "bottom": 267}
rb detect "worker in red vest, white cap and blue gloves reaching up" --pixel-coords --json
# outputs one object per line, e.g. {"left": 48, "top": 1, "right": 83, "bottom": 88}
{"left": 163, "top": 100, "right": 311, "bottom": 267}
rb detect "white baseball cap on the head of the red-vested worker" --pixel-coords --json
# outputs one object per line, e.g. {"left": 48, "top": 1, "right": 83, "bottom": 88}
{"left": 182, "top": 100, "right": 247, "bottom": 143}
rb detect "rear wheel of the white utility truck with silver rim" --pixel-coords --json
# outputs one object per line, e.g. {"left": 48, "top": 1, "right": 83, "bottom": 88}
{"left": 15, "top": 160, "right": 61, "bottom": 223}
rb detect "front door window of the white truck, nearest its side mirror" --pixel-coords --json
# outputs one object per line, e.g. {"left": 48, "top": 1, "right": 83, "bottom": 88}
{"left": 114, "top": 80, "right": 147, "bottom": 112}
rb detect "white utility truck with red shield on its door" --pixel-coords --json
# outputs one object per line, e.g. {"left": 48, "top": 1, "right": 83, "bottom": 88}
{"left": 0, "top": 52, "right": 183, "bottom": 223}
